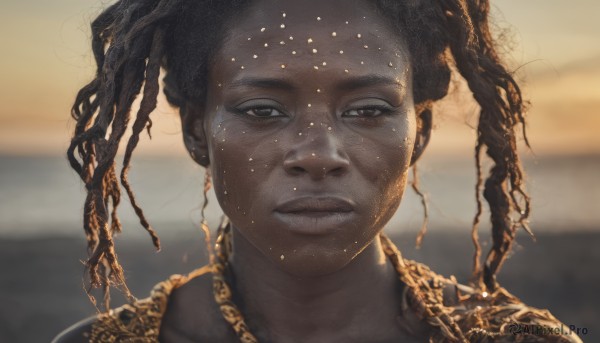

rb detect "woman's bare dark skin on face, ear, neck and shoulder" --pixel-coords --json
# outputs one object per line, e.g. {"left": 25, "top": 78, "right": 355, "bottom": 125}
{"left": 50, "top": 0, "right": 421, "bottom": 342}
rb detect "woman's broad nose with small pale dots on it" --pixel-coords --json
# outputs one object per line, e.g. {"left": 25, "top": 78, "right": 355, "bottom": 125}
{"left": 283, "top": 127, "right": 350, "bottom": 180}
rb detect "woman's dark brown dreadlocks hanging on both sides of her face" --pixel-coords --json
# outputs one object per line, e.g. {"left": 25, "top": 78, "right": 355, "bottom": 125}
{"left": 67, "top": 0, "right": 530, "bottom": 307}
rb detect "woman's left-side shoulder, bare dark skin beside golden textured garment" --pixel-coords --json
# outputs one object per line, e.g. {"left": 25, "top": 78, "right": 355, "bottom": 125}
{"left": 52, "top": 267, "right": 228, "bottom": 343}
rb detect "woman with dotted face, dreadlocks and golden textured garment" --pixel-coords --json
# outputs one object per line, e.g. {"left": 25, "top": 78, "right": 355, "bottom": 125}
{"left": 56, "top": 0, "right": 580, "bottom": 342}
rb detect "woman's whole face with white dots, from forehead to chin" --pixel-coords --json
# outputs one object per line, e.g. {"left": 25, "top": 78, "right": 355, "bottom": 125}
{"left": 192, "top": 0, "right": 416, "bottom": 276}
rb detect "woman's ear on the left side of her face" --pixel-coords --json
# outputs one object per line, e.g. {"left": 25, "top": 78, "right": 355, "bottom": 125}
{"left": 179, "top": 102, "right": 210, "bottom": 167}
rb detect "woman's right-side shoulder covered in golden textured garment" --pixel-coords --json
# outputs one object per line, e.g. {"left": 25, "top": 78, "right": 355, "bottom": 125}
{"left": 405, "top": 260, "right": 582, "bottom": 343}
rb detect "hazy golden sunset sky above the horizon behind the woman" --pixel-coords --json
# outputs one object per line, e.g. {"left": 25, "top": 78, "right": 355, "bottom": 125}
{"left": 0, "top": 0, "right": 600, "bottom": 155}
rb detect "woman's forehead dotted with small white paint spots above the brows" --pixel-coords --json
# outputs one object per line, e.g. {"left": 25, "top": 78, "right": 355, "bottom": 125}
{"left": 214, "top": 0, "right": 408, "bottom": 84}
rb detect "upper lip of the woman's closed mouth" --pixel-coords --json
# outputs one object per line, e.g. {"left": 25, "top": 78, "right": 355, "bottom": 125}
{"left": 275, "top": 196, "right": 354, "bottom": 215}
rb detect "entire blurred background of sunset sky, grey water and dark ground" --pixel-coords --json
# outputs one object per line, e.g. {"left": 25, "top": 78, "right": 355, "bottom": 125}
{"left": 0, "top": 0, "right": 600, "bottom": 342}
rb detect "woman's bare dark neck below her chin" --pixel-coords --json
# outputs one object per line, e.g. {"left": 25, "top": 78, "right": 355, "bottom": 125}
{"left": 231, "top": 228, "right": 401, "bottom": 342}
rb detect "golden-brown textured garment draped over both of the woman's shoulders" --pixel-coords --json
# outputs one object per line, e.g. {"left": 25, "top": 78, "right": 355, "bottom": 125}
{"left": 90, "top": 259, "right": 582, "bottom": 343}
